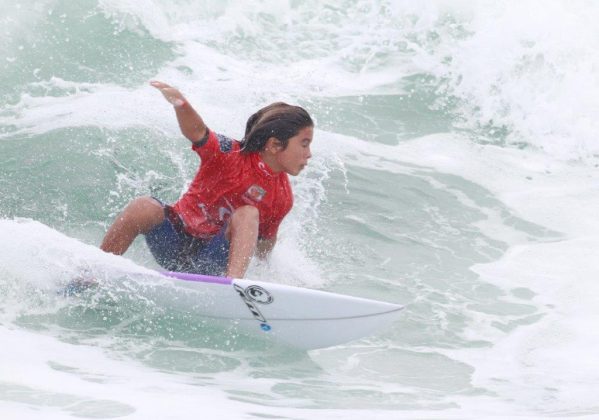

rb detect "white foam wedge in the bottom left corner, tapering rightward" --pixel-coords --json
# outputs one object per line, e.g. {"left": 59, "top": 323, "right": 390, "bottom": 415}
{"left": 0, "top": 326, "right": 247, "bottom": 419}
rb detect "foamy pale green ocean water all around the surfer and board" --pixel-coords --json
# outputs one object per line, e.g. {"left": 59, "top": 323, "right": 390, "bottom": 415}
{"left": 0, "top": 0, "right": 599, "bottom": 420}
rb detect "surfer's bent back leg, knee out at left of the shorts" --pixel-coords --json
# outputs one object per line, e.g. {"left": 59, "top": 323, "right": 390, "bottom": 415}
{"left": 100, "top": 197, "right": 164, "bottom": 255}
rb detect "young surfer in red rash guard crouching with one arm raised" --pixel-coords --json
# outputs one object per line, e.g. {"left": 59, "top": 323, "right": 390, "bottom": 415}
{"left": 101, "top": 81, "right": 314, "bottom": 278}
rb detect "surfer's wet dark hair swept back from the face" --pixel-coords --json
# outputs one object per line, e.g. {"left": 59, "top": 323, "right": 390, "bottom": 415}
{"left": 241, "top": 102, "right": 314, "bottom": 153}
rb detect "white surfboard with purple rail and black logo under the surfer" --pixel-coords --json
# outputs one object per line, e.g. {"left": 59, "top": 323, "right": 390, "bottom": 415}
{"left": 155, "top": 272, "right": 403, "bottom": 350}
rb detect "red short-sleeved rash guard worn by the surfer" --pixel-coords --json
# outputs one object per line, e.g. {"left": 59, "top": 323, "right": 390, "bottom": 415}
{"left": 172, "top": 130, "right": 293, "bottom": 239}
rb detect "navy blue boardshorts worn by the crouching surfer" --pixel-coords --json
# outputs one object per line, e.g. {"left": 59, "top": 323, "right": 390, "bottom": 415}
{"left": 145, "top": 198, "right": 229, "bottom": 276}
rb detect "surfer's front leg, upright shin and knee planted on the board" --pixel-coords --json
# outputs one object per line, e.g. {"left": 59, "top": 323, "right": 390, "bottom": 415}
{"left": 225, "top": 206, "right": 260, "bottom": 278}
